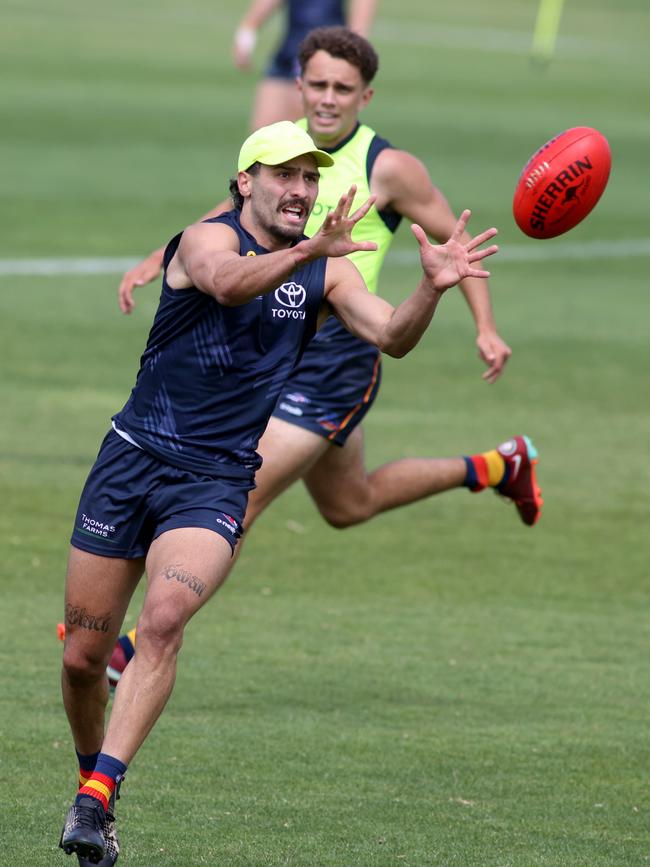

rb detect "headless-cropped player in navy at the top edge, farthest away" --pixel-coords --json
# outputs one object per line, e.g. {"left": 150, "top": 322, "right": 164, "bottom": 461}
{"left": 233, "top": 0, "right": 377, "bottom": 129}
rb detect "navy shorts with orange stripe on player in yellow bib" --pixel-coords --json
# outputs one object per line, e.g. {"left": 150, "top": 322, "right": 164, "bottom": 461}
{"left": 273, "top": 329, "right": 381, "bottom": 446}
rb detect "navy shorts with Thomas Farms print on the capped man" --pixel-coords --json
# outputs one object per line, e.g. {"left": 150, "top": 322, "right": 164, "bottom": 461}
{"left": 70, "top": 430, "right": 255, "bottom": 560}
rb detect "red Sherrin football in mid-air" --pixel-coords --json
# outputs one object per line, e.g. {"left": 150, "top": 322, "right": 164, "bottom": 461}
{"left": 512, "top": 126, "right": 612, "bottom": 238}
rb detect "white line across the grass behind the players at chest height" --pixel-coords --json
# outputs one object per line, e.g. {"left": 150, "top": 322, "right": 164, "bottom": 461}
{"left": 0, "top": 238, "right": 650, "bottom": 277}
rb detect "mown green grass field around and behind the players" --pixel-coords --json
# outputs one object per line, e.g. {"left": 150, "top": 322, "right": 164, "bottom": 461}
{"left": 0, "top": 0, "right": 650, "bottom": 867}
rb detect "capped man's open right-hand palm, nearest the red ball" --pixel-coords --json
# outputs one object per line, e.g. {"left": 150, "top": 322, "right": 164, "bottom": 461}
{"left": 411, "top": 210, "right": 499, "bottom": 292}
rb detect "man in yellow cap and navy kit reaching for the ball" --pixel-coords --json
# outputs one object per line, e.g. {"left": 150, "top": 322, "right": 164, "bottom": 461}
{"left": 60, "top": 122, "right": 497, "bottom": 865}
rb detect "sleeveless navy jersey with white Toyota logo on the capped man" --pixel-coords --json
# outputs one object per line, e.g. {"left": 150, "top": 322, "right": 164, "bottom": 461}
{"left": 113, "top": 211, "right": 327, "bottom": 476}
